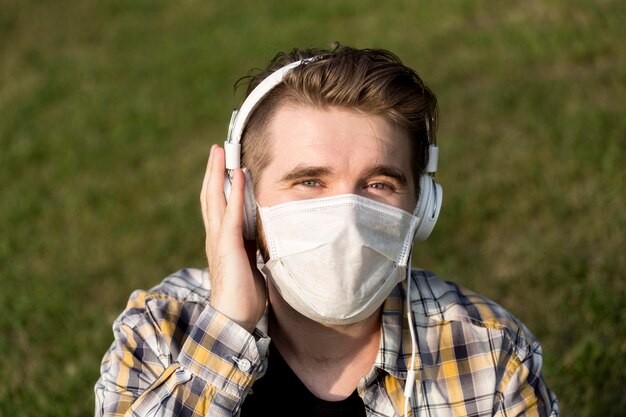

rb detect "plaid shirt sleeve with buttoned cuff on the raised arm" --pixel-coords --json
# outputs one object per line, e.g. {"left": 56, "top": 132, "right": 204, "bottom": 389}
{"left": 95, "top": 292, "right": 269, "bottom": 417}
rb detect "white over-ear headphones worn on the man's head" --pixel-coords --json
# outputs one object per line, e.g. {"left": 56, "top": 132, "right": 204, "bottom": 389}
{"left": 224, "top": 57, "right": 443, "bottom": 241}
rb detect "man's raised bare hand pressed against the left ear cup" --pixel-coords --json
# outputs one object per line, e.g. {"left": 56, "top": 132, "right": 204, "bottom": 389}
{"left": 200, "top": 145, "right": 267, "bottom": 333}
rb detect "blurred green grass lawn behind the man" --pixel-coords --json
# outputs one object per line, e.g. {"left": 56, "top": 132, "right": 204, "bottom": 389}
{"left": 0, "top": 0, "right": 626, "bottom": 416}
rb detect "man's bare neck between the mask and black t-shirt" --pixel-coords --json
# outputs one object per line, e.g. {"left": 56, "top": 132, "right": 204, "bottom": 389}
{"left": 268, "top": 282, "right": 381, "bottom": 401}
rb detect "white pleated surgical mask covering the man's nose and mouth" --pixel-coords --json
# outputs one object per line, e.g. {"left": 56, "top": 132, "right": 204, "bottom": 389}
{"left": 259, "top": 194, "right": 418, "bottom": 325}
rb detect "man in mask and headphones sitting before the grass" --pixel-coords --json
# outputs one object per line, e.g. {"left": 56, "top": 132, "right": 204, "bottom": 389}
{"left": 96, "top": 46, "right": 559, "bottom": 417}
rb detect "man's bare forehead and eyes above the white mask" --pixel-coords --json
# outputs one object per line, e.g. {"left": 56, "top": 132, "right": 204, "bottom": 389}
{"left": 256, "top": 106, "right": 416, "bottom": 213}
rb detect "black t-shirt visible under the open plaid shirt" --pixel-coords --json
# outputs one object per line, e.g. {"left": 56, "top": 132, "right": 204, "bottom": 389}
{"left": 241, "top": 343, "right": 365, "bottom": 417}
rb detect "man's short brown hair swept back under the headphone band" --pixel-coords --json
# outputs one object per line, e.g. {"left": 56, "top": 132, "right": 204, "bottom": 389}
{"left": 237, "top": 45, "right": 438, "bottom": 195}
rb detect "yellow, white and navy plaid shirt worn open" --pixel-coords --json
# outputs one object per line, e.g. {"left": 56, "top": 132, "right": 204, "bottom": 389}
{"left": 95, "top": 269, "right": 559, "bottom": 417}
